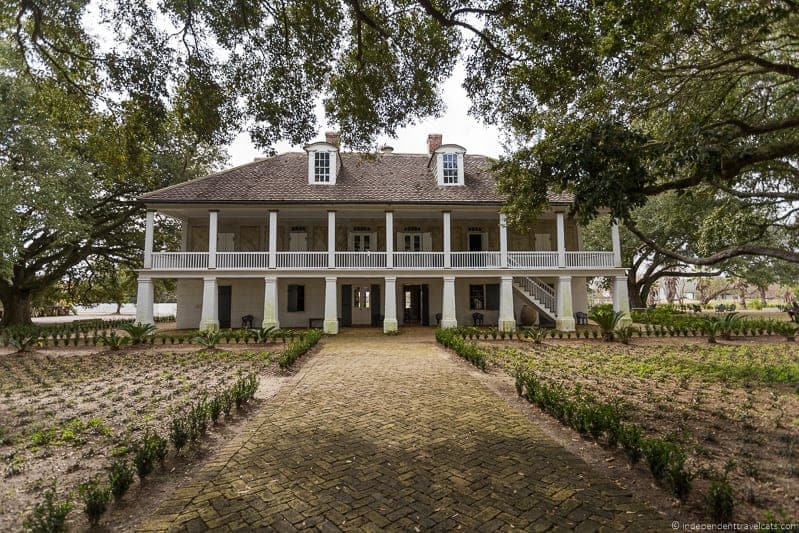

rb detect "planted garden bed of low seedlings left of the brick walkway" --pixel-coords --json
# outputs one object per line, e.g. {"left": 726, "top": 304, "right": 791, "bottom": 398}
{"left": 0, "top": 342, "right": 284, "bottom": 530}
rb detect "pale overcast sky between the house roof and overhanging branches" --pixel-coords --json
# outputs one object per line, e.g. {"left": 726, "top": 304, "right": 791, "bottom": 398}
{"left": 227, "top": 66, "right": 503, "bottom": 166}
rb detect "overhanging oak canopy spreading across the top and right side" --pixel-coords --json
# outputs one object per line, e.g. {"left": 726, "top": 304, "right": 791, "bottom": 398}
{"left": 0, "top": 0, "right": 799, "bottom": 320}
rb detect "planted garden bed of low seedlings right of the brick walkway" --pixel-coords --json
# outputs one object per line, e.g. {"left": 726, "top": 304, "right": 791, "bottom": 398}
{"left": 479, "top": 337, "right": 799, "bottom": 522}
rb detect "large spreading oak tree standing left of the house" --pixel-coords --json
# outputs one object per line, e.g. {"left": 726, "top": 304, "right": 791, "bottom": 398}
{"left": 0, "top": 41, "right": 219, "bottom": 325}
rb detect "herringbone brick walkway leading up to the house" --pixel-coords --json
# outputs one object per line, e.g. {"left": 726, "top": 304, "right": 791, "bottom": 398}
{"left": 142, "top": 329, "right": 665, "bottom": 531}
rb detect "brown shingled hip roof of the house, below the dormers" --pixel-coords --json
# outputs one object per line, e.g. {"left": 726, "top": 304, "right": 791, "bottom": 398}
{"left": 140, "top": 152, "right": 572, "bottom": 205}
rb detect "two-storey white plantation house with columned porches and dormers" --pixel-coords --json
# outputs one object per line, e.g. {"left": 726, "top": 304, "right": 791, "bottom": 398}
{"left": 137, "top": 133, "right": 628, "bottom": 333}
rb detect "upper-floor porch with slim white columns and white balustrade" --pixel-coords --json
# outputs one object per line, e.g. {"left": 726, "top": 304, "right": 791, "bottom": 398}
{"left": 143, "top": 205, "right": 621, "bottom": 276}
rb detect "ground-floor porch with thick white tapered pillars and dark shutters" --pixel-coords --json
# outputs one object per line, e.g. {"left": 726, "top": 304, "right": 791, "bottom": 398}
{"left": 137, "top": 275, "right": 628, "bottom": 334}
